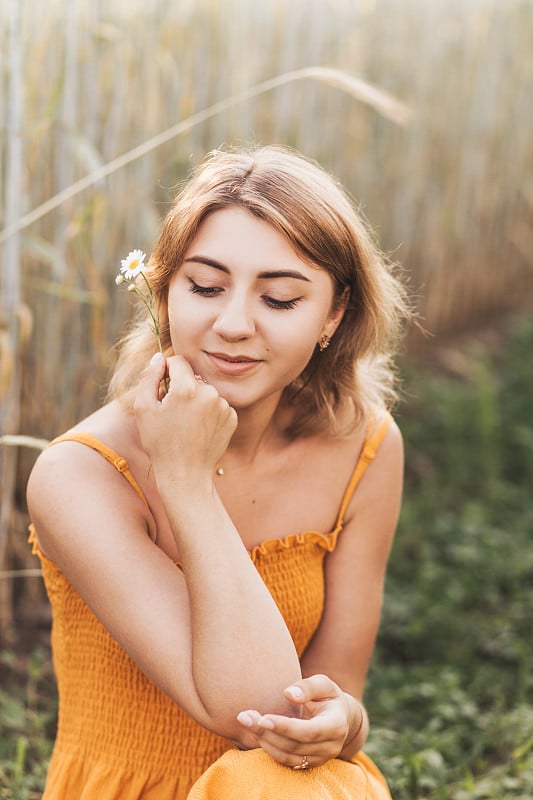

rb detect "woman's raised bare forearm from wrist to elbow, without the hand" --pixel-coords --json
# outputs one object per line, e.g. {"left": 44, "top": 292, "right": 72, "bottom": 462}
{"left": 158, "top": 478, "right": 301, "bottom": 737}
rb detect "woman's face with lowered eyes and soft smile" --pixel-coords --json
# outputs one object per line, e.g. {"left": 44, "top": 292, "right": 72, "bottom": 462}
{"left": 168, "top": 206, "right": 342, "bottom": 411}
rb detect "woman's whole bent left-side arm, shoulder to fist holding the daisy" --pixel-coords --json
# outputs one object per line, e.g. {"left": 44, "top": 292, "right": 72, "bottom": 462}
{"left": 28, "top": 359, "right": 301, "bottom": 744}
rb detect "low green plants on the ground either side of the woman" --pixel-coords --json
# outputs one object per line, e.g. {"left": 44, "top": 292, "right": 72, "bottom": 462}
{"left": 0, "top": 320, "right": 533, "bottom": 800}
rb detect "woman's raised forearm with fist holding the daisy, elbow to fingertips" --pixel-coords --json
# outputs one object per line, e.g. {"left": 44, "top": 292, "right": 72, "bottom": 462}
{"left": 134, "top": 356, "right": 301, "bottom": 738}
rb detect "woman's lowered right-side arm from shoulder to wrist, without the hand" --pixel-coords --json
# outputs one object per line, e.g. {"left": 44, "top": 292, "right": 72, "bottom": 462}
{"left": 302, "top": 423, "right": 403, "bottom": 699}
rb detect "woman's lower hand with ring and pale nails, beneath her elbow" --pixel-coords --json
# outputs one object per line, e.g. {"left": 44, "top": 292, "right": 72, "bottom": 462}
{"left": 237, "top": 675, "right": 353, "bottom": 768}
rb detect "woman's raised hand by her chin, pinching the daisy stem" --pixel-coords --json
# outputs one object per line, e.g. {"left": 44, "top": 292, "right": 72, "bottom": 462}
{"left": 134, "top": 353, "right": 237, "bottom": 485}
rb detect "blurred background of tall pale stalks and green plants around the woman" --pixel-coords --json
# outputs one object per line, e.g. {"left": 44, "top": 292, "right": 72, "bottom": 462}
{"left": 0, "top": 0, "right": 533, "bottom": 800}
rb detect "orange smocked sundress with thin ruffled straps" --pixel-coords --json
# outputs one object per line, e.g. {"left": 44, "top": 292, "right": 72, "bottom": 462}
{"left": 30, "top": 416, "right": 390, "bottom": 800}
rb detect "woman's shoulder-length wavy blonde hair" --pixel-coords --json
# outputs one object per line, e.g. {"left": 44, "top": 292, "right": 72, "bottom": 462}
{"left": 109, "top": 146, "right": 409, "bottom": 436}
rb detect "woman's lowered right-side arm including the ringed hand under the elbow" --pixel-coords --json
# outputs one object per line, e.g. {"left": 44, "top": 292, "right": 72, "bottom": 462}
{"left": 235, "top": 418, "right": 403, "bottom": 766}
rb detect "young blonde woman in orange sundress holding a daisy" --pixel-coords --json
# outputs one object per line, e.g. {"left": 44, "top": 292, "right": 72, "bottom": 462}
{"left": 28, "top": 147, "right": 407, "bottom": 800}
